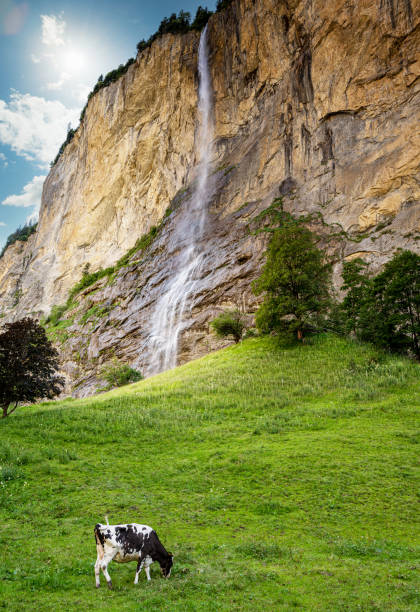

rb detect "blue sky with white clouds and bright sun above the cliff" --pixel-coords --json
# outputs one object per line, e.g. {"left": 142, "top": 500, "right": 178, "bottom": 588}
{"left": 0, "top": 0, "right": 216, "bottom": 248}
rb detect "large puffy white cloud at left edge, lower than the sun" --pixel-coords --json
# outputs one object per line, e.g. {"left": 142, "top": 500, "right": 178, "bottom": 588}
{"left": 0, "top": 91, "right": 79, "bottom": 168}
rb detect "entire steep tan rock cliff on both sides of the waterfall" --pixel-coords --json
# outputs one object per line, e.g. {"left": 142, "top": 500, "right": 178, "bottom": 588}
{"left": 0, "top": 0, "right": 420, "bottom": 394}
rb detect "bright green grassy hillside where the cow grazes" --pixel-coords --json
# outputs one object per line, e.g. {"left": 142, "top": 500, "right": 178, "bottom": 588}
{"left": 0, "top": 338, "right": 420, "bottom": 612}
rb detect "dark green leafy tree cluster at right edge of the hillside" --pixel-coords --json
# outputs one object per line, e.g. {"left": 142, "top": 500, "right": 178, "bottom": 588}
{"left": 342, "top": 251, "right": 420, "bottom": 359}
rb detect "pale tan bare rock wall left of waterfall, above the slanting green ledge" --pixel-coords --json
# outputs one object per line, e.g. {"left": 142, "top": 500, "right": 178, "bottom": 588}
{"left": 0, "top": 35, "right": 197, "bottom": 316}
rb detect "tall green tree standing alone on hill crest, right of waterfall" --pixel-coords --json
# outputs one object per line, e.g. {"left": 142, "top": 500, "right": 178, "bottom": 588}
{"left": 254, "top": 214, "right": 331, "bottom": 340}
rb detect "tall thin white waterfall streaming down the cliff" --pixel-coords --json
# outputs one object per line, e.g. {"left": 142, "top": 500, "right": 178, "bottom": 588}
{"left": 148, "top": 26, "right": 213, "bottom": 374}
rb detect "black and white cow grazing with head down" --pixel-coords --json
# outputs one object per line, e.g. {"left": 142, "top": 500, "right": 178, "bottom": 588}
{"left": 94, "top": 523, "right": 173, "bottom": 589}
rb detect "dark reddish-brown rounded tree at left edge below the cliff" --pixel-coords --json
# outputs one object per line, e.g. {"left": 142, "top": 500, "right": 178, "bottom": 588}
{"left": 0, "top": 318, "right": 64, "bottom": 418}
